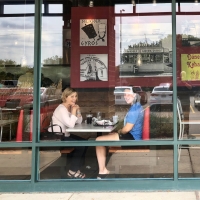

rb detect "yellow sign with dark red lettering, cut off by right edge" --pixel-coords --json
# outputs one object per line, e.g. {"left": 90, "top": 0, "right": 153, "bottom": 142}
{"left": 181, "top": 54, "right": 200, "bottom": 81}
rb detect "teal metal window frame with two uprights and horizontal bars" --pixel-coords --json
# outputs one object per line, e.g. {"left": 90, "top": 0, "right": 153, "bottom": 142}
{"left": 0, "top": 0, "right": 200, "bottom": 192}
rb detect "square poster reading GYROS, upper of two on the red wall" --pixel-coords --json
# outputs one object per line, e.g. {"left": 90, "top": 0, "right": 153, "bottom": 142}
{"left": 80, "top": 19, "right": 107, "bottom": 46}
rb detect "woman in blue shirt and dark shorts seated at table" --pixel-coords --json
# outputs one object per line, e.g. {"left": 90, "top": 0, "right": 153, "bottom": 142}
{"left": 96, "top": 87, "right": 144, "bottom": 179}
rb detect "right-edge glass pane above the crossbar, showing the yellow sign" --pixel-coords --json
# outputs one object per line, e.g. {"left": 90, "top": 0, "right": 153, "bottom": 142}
{"left": 176, "top": 2, "right": 200, "bottom": 139}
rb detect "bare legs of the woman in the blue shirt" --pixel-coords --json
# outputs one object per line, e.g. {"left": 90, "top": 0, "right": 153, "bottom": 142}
{"left": 96, "top": 133, "right": 119, "bottom": 174}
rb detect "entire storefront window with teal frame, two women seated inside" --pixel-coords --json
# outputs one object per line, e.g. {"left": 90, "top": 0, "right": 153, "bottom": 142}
{"left": 0, "top": 0, "right": 200, "bottom": 190}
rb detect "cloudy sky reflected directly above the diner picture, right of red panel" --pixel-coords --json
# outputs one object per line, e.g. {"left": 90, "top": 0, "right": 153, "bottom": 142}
{"left": 115, "top": 16, "right": 172, "bottom": 66}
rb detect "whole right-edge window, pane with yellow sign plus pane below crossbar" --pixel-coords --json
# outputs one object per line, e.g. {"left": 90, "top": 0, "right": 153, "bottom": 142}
{"left": 176, "top": 1, "right": 200, "bottom": 178}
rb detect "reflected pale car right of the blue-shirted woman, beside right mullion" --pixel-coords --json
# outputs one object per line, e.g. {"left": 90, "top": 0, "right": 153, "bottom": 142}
{"left": 149, "top": 86, "right": 173, "bottom": 104}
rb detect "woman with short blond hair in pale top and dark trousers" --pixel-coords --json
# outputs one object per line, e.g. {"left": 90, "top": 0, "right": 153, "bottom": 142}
{"left": 49, "top": 87, "right": 86, "bottom": 178}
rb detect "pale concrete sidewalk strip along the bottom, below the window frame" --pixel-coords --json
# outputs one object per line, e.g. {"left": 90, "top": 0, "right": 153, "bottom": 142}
{"left": 0, "top": 191, "right": 199, "bottom": 200}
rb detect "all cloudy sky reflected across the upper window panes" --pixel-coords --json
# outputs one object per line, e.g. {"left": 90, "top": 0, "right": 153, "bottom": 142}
{"left": 0, "top": 3, "right": 200, "bottom": 66}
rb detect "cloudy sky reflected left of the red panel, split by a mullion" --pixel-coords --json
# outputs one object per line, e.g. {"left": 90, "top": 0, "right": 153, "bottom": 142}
{"left": 0, "top": 17, "right": 63, "bottom": 67}
